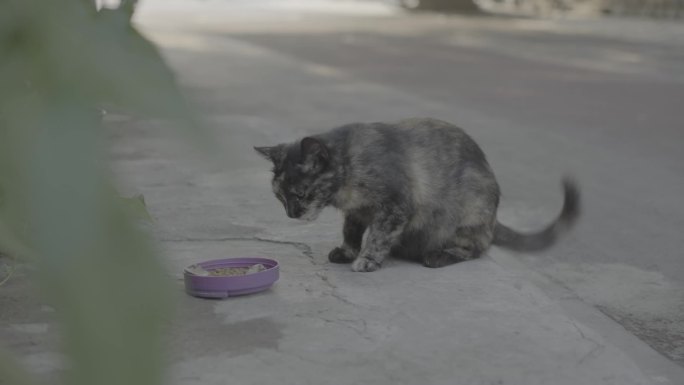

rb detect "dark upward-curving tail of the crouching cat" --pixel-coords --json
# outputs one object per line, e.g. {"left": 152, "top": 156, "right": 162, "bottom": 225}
{"left": 493, "top": 177, "right": 580, "bottom": 251}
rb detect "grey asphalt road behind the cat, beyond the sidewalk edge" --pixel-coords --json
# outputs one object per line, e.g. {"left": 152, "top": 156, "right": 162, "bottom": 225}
{"left": 140, "top": 1, "right": 684, "bottom": 364}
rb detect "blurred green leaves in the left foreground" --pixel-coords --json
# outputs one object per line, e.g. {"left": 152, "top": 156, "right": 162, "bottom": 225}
{"left": 0, "top": 0, "right": 197, "bottom": 385}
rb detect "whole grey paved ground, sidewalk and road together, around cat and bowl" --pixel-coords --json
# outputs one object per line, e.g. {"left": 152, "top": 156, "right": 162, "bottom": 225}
{"left": 0, "top": 1, "right": 684, "bottom": 385}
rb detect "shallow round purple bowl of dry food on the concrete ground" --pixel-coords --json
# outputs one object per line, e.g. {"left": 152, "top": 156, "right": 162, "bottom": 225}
{"left": 183, "top": 258, "right": 280, "bottom": 298}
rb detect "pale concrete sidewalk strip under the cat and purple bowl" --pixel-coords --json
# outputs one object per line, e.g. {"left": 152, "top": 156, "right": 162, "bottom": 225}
{"left": 105, "top": 23, "right": 684, "bottom": 385}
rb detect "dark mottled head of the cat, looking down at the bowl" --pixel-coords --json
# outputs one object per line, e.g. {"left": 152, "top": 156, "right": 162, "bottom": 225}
{"left": 254, "top": 137, "right": 336, "bottom": 221}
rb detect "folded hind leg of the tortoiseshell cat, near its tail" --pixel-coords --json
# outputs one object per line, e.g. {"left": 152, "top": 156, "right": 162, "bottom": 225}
{"left": 423, "top": 225, "right": 493, "bottom": 268}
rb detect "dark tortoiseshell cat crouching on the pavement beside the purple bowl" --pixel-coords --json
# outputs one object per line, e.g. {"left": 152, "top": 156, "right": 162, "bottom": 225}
{"left": 255, "top": 119, "right": 579, "bottom": 271}
